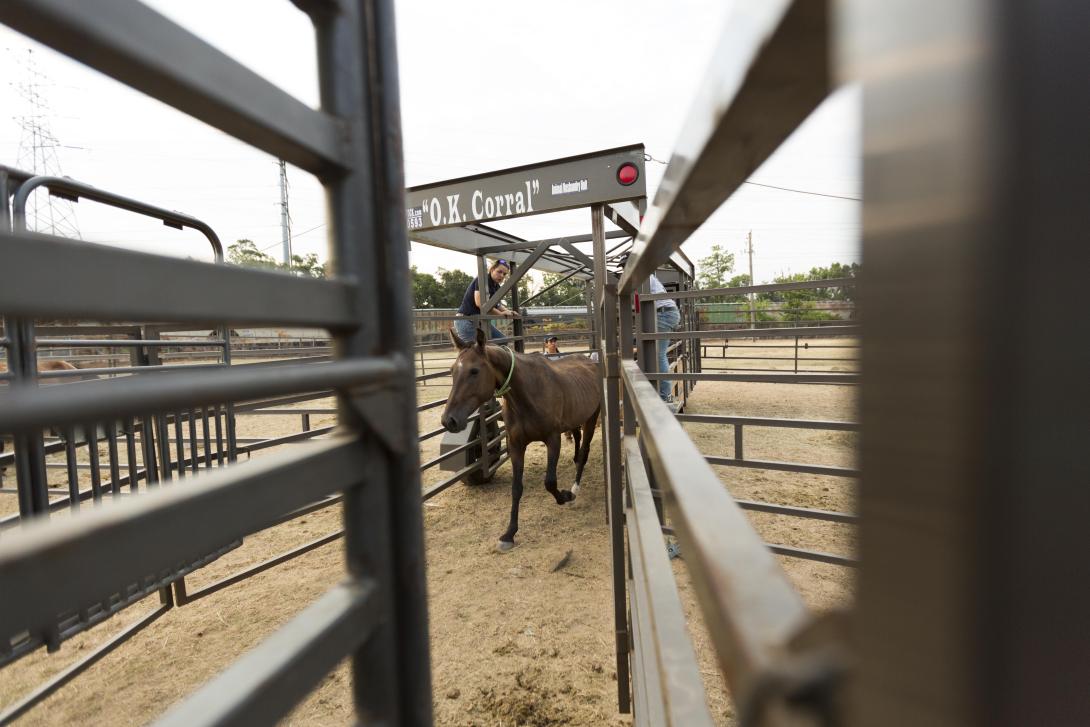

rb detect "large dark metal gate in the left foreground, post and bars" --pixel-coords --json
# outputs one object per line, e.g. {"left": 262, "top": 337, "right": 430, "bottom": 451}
{"left": 0, "top": 0, "right": 431, "bottom": 725}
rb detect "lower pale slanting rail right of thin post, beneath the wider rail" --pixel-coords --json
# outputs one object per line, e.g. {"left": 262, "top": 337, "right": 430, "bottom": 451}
{"left": 625, "top": 435, "right": 714, "bottom": 727}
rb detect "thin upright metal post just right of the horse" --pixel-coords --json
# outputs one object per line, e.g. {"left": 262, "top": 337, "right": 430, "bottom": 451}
{"left": 591, "top": 205, "right": 631, "bottom": 713}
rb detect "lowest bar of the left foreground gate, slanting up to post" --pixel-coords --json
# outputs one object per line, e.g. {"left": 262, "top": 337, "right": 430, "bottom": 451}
{"left": 156, "top": 580, "right": 378, "bottom": 727}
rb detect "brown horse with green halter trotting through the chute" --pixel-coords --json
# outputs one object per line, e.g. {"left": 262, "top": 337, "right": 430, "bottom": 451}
{"left": 441, "top": 330, "right": 602, "bottom": 553}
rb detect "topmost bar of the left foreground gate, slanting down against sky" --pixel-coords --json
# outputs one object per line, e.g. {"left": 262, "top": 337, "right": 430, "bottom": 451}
{"left": 0, "top": 0, "right": 350, "bottom": 174}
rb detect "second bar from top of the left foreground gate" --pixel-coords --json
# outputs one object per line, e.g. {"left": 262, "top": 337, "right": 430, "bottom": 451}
{"left": 0, "top": 232, "right": 360, "bottom": 329}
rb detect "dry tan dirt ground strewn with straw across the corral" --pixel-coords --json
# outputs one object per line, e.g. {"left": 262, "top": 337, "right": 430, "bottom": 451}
{"left": 0, "top": 344, "right": 856, "bottom": 727}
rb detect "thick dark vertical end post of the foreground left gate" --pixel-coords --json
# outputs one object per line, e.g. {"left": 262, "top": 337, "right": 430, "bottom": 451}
{"left": 306, "top": 0, "right": 432, "bottom": 726}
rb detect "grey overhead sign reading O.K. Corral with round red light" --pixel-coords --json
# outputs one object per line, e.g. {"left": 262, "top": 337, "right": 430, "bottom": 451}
{"left": 405, "top": 144, "right": 647, "bottom": 235}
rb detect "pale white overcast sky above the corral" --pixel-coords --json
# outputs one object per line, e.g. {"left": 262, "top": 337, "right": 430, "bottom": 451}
{"left": 0, "top": 0, "right": 860, "bottom": 281}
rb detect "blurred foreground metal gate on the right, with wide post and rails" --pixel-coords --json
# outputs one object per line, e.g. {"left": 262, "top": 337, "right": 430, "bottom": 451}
{"left": 595, "top": 0, "right": 1090, "bottom": 727}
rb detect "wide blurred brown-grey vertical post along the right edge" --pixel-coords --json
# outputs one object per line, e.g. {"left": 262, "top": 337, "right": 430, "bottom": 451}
{"left": 845, "top": 0, "right": 1090, "bottom": 727}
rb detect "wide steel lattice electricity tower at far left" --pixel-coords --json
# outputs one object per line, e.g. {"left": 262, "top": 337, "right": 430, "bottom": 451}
{"left": 10, "top": 48, "right": 83, "bottom": 240}
